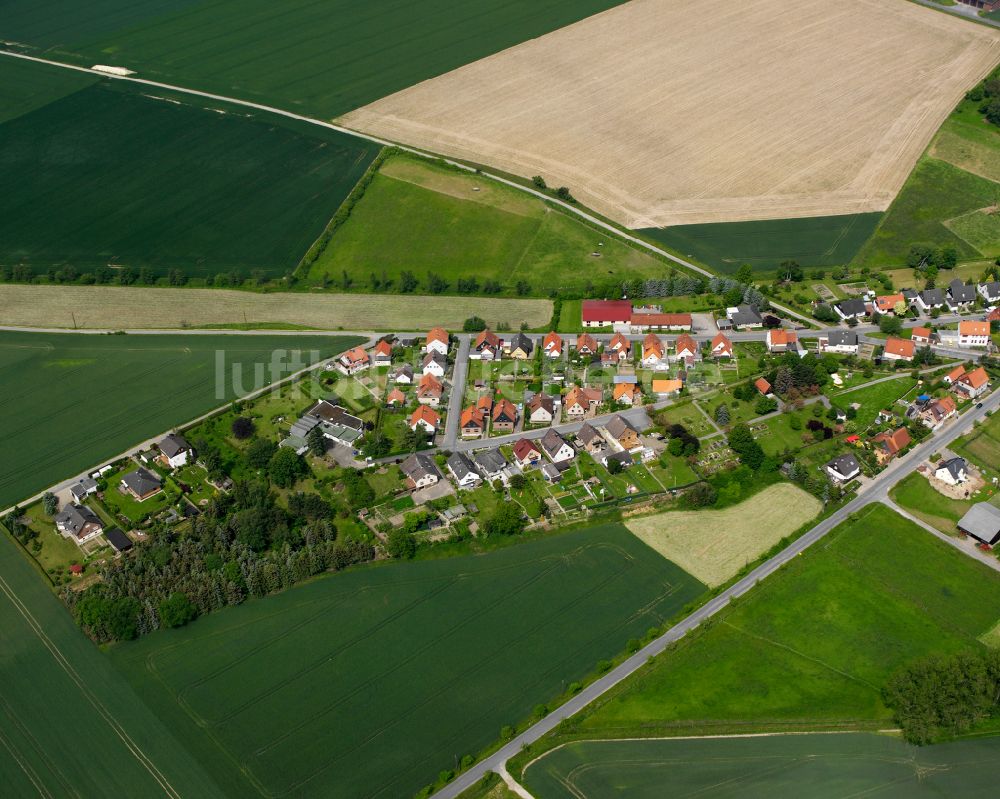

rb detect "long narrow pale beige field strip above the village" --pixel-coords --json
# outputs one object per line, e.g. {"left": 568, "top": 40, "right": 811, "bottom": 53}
{"left": 0, "top": 284, "right": 552, "bottom": 331}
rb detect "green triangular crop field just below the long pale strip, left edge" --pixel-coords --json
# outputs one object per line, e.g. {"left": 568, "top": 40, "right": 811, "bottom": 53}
{"left": 0, "top": 330, "right": 358, "bottom": 507}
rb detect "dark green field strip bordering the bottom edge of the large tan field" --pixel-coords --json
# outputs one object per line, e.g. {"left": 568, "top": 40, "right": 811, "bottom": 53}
{"left": 639, "top": 213, "right": 882, "bottom": 274}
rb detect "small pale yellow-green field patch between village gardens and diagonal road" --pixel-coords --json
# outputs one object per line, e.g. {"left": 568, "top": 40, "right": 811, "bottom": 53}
{"left": 625, "top": 483, "right": 822, "bottom": 587}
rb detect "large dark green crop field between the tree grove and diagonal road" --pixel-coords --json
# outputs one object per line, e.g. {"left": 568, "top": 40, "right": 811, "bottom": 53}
{"left": 112, "top": 525, "right": 704, "bottom": 797}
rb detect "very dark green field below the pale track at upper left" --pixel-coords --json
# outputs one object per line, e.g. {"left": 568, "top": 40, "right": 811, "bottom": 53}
{"left": 0, "top": 58, "right": 378, "bottom": 277}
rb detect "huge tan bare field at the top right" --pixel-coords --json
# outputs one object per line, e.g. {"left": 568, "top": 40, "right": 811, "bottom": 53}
{"left": 340, "top": 0, "right": 1000, "bottom": 228}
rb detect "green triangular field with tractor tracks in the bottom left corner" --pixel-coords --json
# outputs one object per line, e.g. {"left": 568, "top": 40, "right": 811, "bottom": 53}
{"left": 0, "top": 527, "right": 223, "bottom": 799}
